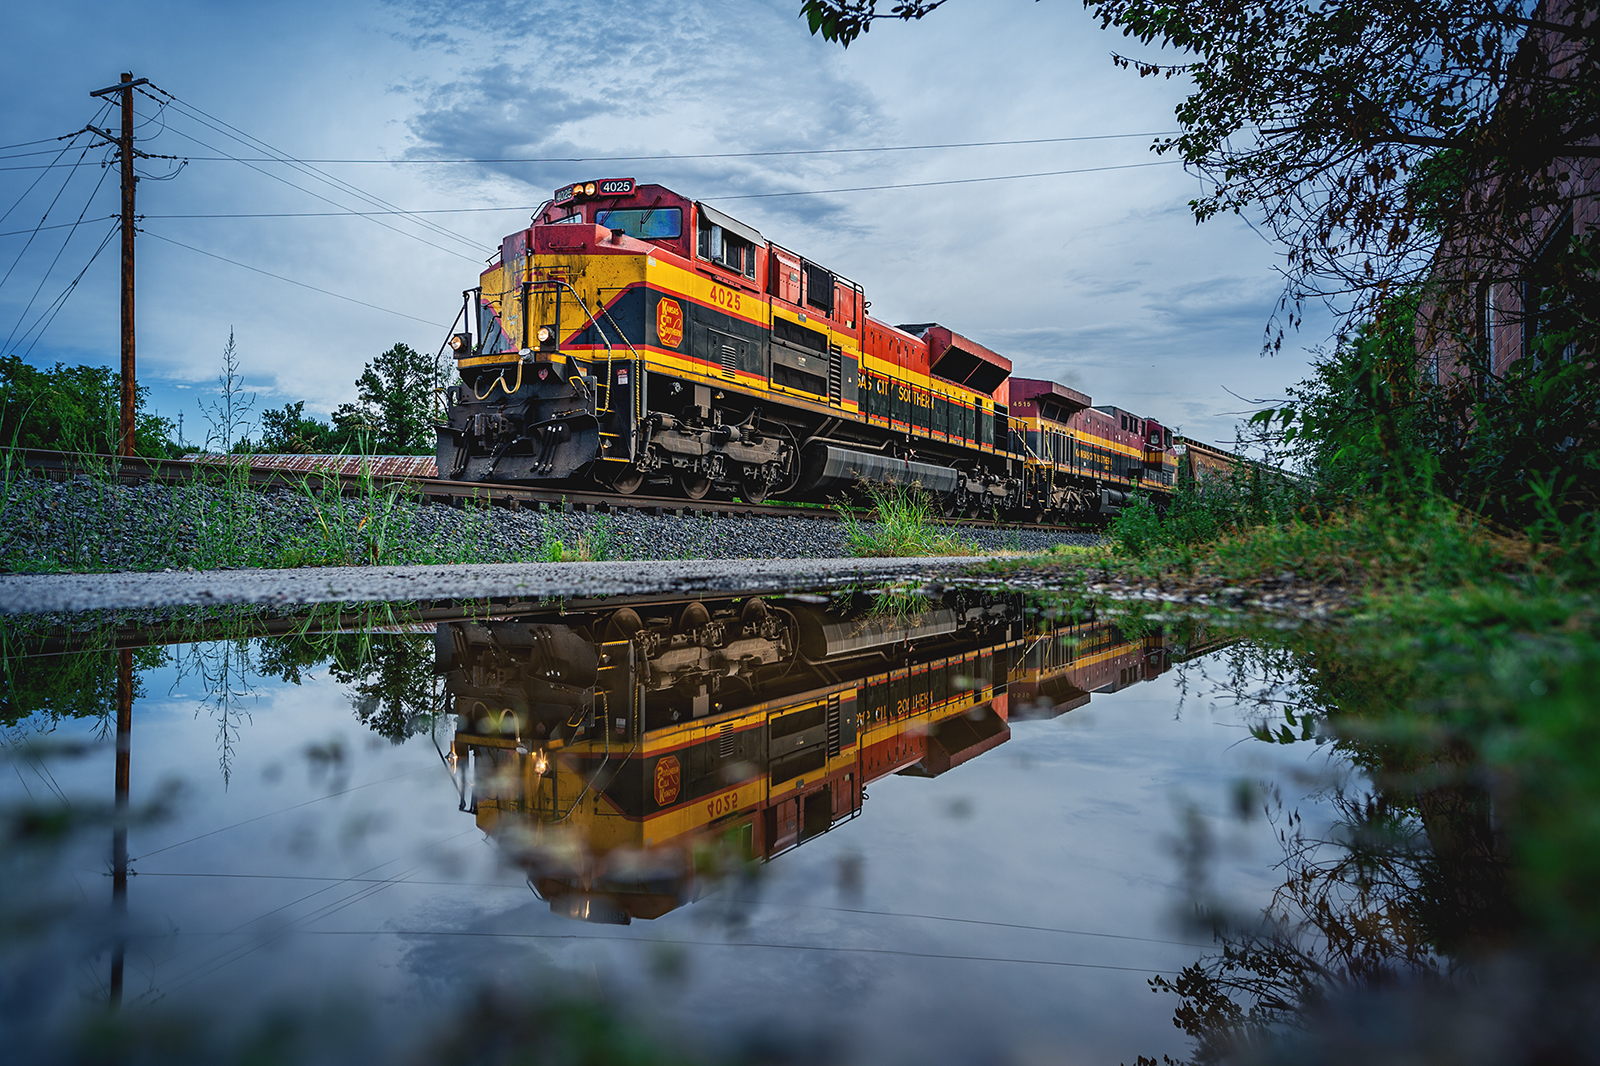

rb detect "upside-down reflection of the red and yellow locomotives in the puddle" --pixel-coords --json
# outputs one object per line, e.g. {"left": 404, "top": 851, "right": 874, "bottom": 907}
{"left": 437, "top": 592, "right": 1203, "bottom": 922}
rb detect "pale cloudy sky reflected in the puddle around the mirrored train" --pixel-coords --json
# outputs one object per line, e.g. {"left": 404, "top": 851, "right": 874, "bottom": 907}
{"left": 0, "top": 624, "right": 1322, "bottom": 1063}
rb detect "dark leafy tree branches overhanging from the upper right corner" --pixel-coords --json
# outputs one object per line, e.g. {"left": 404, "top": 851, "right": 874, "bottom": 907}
{"left": 800, "top": 0, "right": 1600, "bottom": 336}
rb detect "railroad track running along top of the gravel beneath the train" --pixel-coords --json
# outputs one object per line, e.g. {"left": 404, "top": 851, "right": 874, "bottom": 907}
{"left": 13, "top": 448, "right": 1098, "bottom": 533}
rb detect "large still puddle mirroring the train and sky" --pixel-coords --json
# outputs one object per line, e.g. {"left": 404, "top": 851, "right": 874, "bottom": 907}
{"left": 0, "top": 591, "right": 1338, "bottom": 1063}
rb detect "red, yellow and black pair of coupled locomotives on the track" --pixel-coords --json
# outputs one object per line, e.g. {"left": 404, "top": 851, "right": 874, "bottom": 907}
{"left": 438, "top": 178, "right": 1203, "bottom": 520}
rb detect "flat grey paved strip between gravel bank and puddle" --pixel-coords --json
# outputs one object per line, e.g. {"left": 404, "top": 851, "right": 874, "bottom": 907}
{"left": 0, "top": 555, "right": 989, "bottom": 615}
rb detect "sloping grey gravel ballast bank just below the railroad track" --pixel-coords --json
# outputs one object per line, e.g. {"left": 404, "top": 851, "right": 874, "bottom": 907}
{"left": 0, "top": 477, "right": 1101, "bottom": 571}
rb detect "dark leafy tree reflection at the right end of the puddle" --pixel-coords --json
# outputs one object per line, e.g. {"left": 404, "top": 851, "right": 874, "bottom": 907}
{"left": 1139, "top": 645, "right": 1515, "bottom": 1063}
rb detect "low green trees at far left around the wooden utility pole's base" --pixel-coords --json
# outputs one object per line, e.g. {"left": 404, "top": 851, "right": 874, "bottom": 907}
{"left": 0, "top": 355, "right": 176, "bottom": 458}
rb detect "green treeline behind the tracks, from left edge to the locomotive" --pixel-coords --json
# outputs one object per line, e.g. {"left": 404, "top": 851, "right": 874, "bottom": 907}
{"left": 0, "top": 336, "right": 448, "bottom": 458}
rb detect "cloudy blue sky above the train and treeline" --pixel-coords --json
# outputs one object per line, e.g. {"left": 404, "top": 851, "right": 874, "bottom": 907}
{"left": 0, "top": 0, "right": 1328, "bottom": 440}
